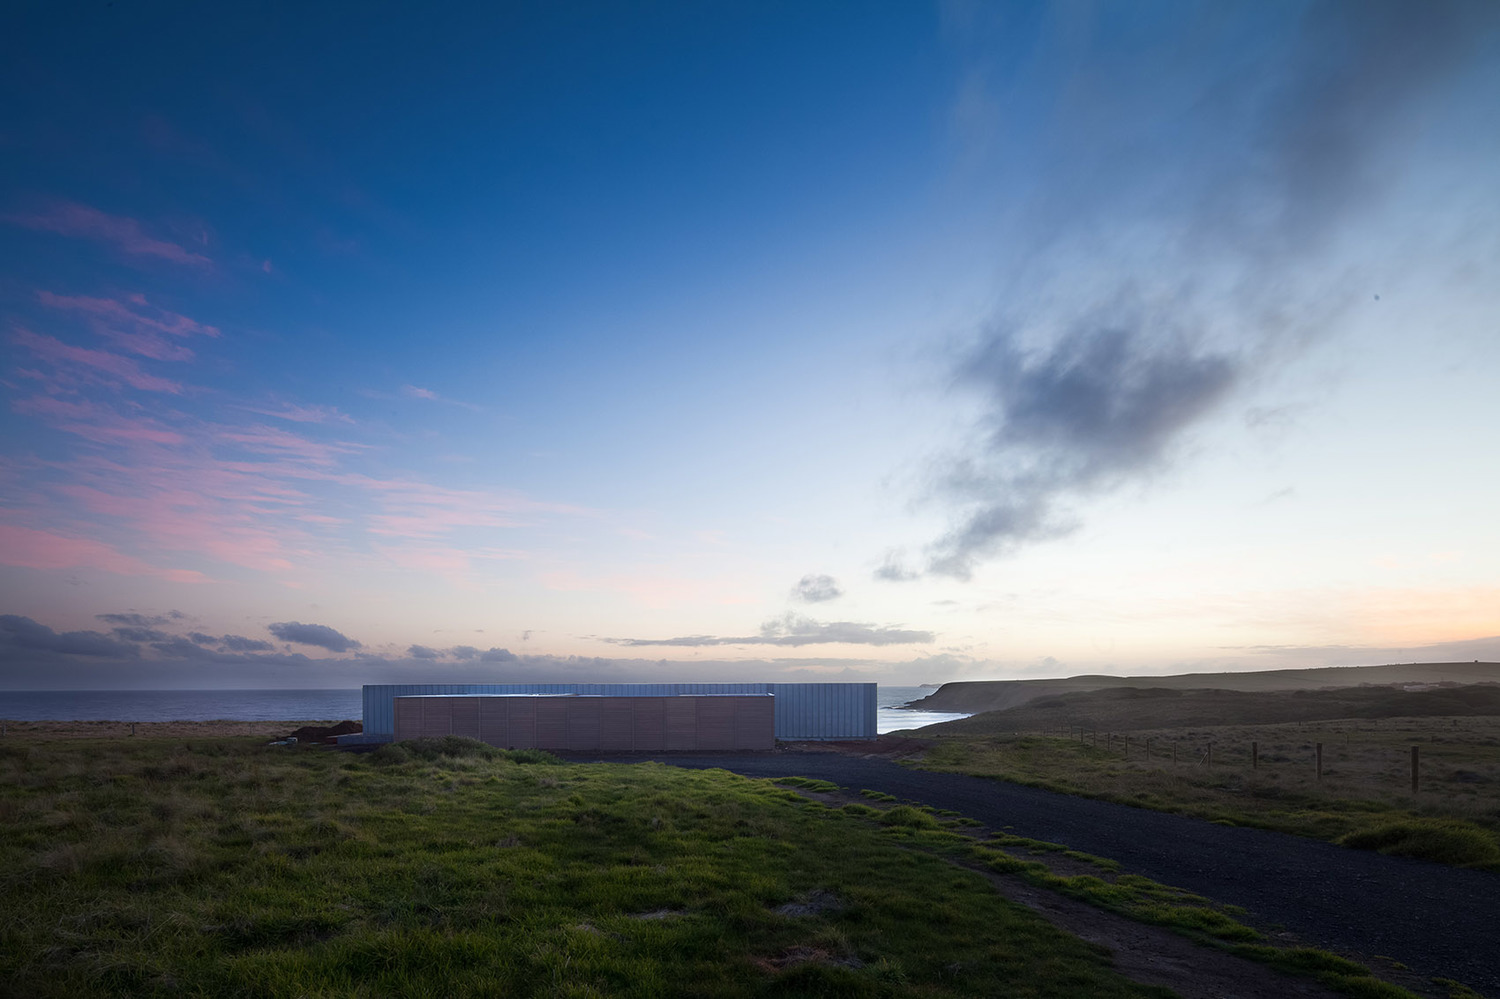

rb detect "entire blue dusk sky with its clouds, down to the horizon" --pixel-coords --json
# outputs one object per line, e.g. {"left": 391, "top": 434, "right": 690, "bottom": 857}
{"left": 0, "top": 0, "right": 1500, "bottom": 690}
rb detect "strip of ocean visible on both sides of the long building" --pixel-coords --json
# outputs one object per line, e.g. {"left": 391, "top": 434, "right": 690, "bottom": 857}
{"left": 0, "top": 687, "right": 968, "bottom": 734}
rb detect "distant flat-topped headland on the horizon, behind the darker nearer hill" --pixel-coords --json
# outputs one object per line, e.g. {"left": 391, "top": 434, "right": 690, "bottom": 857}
{"left": 908, "top": 662, "right": 1500, "bottom": 714}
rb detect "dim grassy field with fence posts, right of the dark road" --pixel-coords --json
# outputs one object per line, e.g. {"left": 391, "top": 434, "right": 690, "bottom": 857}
{"left": 918, "top": 716, "right": 1500, "bottom": 870}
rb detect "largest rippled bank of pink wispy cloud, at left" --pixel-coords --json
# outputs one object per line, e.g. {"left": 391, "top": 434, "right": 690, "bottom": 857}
{"left": 12, "top": 369, "right": 590, "bottom": 585}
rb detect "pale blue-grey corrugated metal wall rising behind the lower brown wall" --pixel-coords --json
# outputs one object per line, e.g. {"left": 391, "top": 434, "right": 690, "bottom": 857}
{"left": 365, "top": 684, "right": 876, "bottom": 740}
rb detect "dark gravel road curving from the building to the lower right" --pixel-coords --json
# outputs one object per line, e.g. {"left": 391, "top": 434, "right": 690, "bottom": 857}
{"left": 576, "top": 753, "right": 1500, "bottom": 996}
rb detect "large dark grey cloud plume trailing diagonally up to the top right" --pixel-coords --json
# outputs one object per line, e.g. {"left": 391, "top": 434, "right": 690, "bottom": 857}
{"left": 924, "top": 0, "right": 1500, "bottom": 579}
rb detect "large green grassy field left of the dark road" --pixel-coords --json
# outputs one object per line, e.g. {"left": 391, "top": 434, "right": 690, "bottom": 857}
{"left": 0, "top": 740, "right": 1167, "bottom": 998}
